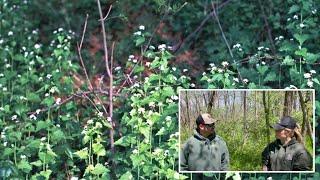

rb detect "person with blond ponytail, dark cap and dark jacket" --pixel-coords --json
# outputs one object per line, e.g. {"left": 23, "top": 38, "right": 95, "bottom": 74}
{"left": 262, "top": 116, "right": 312, "bottom": 171}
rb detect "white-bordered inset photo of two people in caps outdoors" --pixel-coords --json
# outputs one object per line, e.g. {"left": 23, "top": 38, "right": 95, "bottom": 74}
{"left": 179, "top": 89, "right": 315, "bottom": 173}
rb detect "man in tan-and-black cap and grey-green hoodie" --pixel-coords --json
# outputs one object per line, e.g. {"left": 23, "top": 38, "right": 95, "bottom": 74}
{"left": 180, "top": 113, "right": 229, "bottom": 171}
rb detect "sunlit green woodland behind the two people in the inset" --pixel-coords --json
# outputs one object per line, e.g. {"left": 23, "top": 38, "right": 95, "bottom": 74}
{"left": 179, "top": 90, "right": 314, "bottom": 171}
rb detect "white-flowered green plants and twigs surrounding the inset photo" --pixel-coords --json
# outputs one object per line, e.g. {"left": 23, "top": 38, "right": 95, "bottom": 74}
{"left": 0, "top": 0, "right": 320, "bottom": 179}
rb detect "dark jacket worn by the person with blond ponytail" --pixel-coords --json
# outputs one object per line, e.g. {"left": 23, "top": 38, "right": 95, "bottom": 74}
{"left": 262, "top": 138, "right": 312, "bottom": 171}
